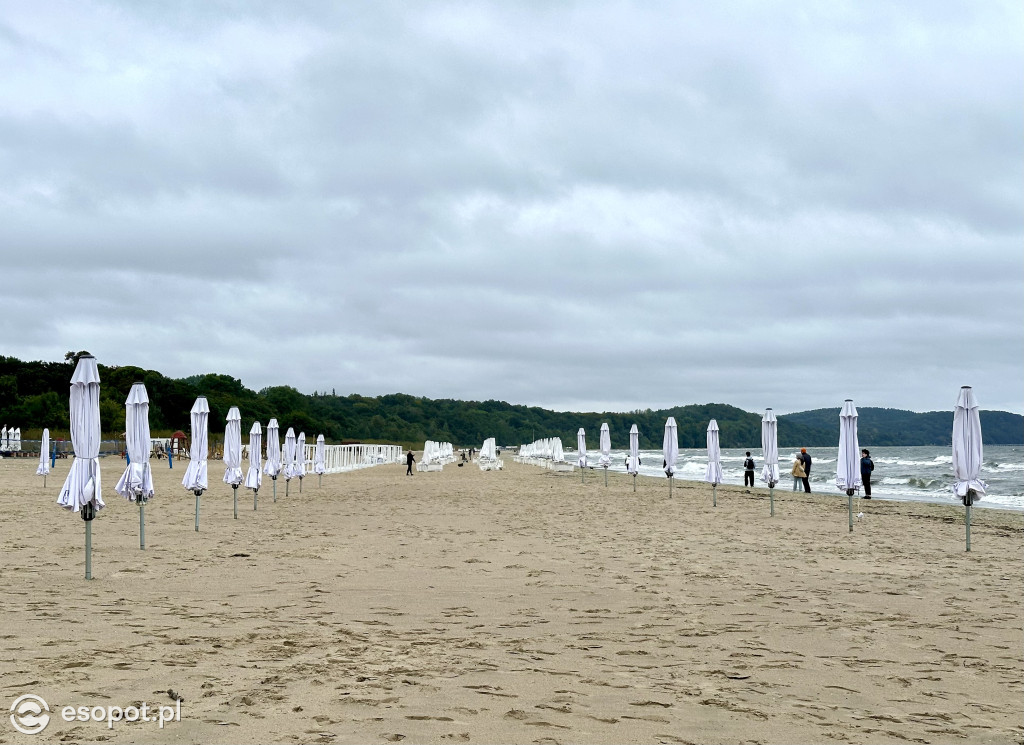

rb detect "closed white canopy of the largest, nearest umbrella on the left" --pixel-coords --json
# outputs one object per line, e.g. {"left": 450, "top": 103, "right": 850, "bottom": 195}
{"left": 57, "top": 355, "right": 105, "bottom": 512}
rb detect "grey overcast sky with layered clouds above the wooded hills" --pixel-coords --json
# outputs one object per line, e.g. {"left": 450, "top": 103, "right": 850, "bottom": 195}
{"left": 0, "top": 0, "right": 1024, "bottom": 412}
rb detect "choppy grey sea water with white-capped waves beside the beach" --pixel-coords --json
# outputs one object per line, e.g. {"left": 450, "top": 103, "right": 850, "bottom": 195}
{"left": 577, "top": 445, "right": 1024, "bottom": 512}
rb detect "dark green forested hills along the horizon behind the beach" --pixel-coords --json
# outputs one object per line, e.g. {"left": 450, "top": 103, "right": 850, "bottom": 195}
{"left": 0, "top": 353, "right": 1024, "bottom": 449}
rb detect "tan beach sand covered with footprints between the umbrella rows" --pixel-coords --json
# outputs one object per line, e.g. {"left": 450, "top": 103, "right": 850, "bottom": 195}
{"left": 0, "top": 456, "right": 1024, "bottom": 743}
